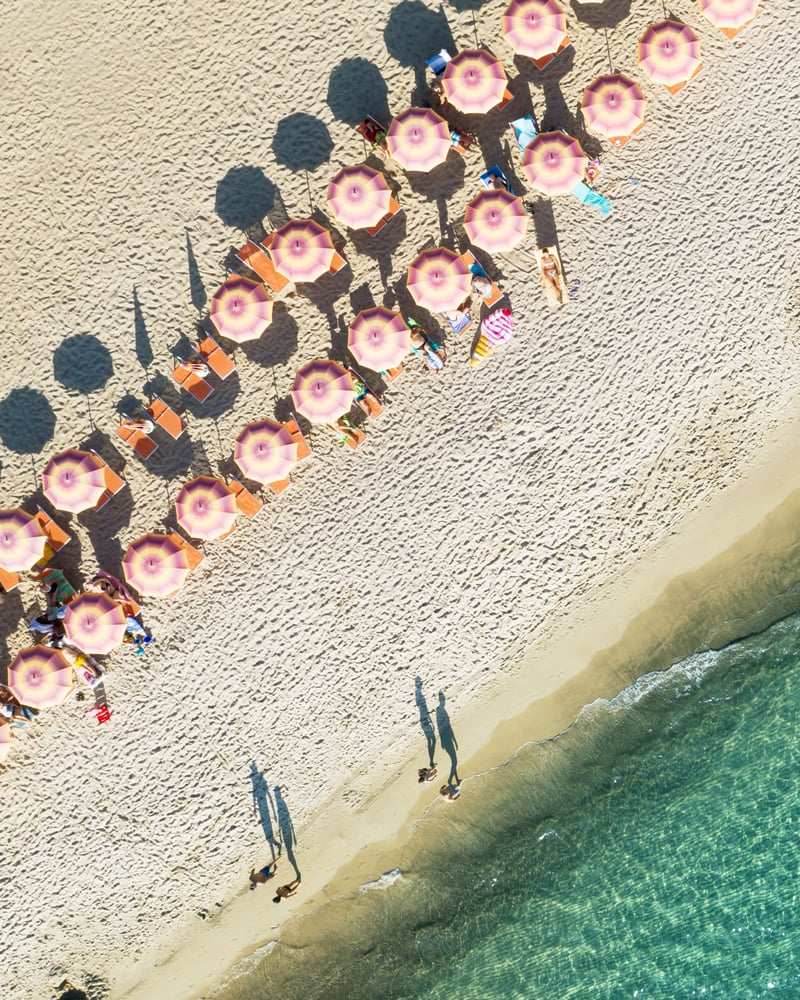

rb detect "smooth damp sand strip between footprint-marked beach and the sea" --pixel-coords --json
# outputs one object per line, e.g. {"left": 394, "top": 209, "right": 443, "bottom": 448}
{"left": 111, "top": 410, "right": 800, "bottom": 1000}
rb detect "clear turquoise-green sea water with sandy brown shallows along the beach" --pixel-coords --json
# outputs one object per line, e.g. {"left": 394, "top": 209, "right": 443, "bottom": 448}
{"left": 211, "top": 616, "right": 800, "bottom": 1000}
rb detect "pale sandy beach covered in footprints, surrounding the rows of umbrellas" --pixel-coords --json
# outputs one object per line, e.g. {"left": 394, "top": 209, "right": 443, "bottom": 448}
{"left": 0, "top": 0, "right": 800, "bottom": 998}
